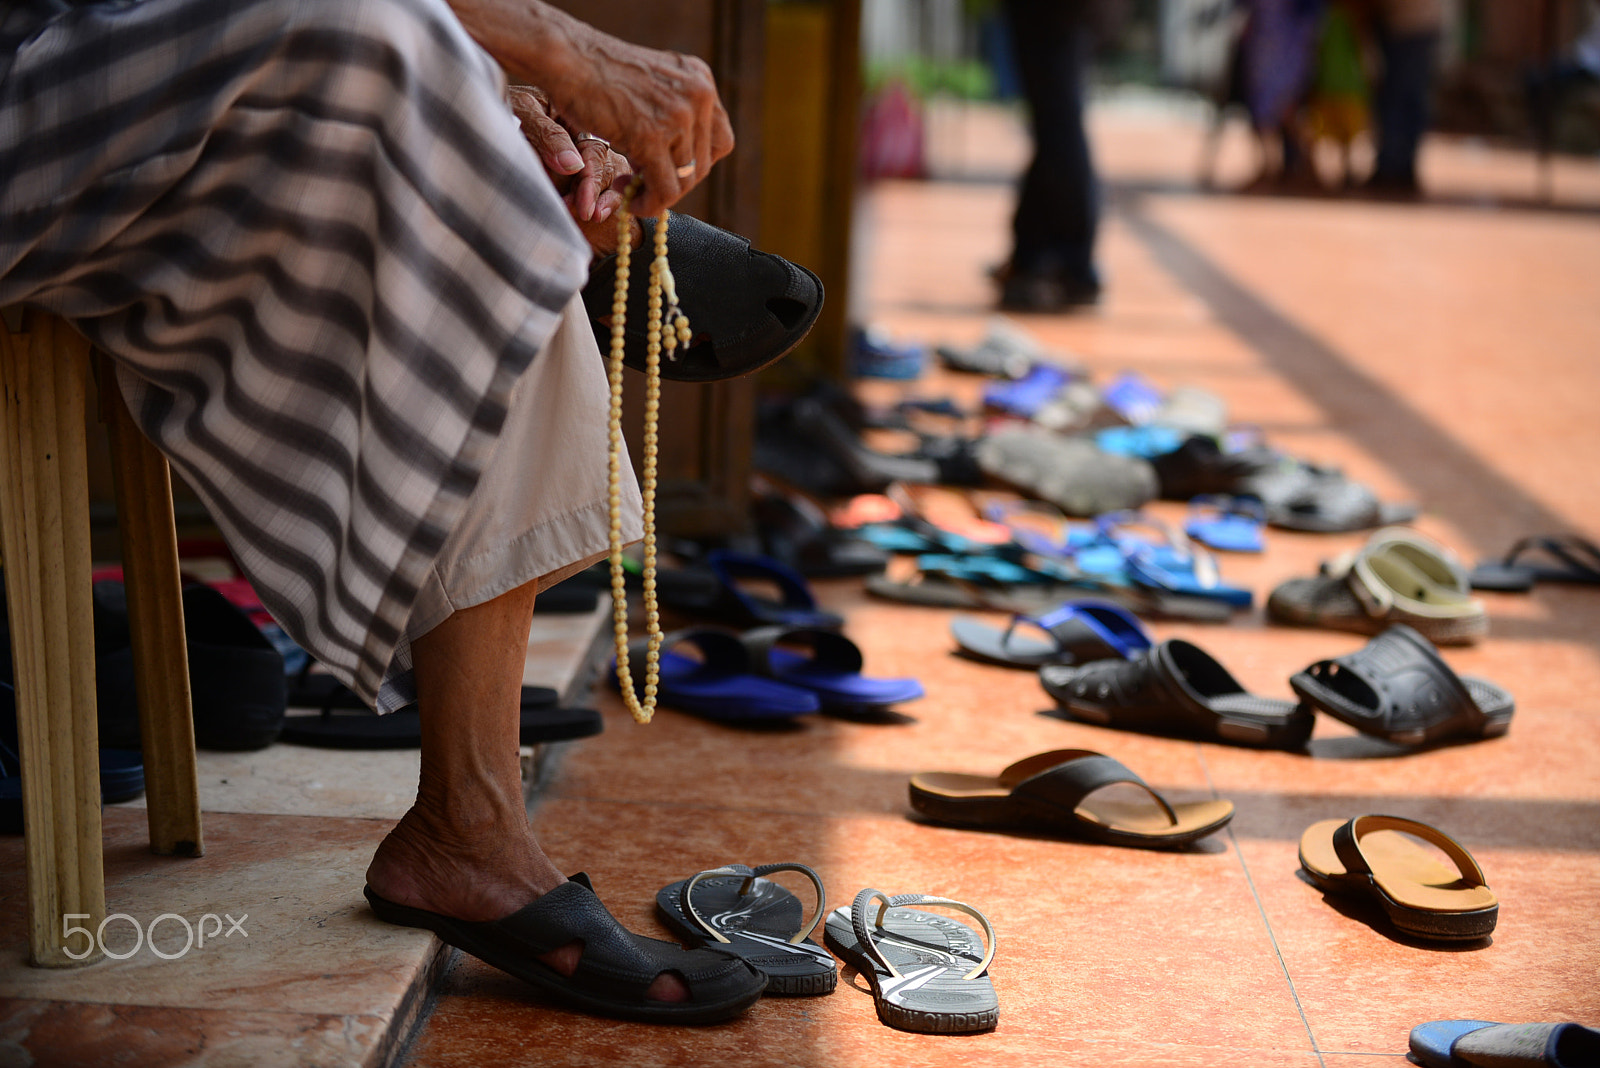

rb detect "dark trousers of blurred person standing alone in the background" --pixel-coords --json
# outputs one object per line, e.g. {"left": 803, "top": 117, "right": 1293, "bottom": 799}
{"left": 1005, "top": 0, "right": 1099, "bottom": 281}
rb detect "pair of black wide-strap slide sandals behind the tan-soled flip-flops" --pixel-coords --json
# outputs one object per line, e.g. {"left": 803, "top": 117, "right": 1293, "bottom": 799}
{"left": 1038, "top": 624, "right": 1515, "bottom": 750}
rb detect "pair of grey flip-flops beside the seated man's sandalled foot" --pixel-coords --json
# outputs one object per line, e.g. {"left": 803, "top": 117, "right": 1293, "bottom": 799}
{"left": 656, "top": 863, "right": 1000, "bottom": 1034}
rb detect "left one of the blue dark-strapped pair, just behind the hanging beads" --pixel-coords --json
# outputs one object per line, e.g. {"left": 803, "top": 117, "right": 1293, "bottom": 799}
{"left": 610, "top": 627, "right": 822, "bottom": 721}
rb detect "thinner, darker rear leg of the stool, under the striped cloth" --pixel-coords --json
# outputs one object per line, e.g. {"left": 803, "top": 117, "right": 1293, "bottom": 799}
{"left": 96, "top": 353, "right": 203, "bottom": 857}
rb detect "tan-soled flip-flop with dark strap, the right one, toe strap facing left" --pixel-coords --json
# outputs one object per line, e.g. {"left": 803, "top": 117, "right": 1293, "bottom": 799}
{"left": 1299, "top": 815, "right": 1499, "bottom": 942}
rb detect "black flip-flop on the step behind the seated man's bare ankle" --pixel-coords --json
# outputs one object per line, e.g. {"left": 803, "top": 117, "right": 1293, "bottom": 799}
{"left": 278, "top": 686, "right": 588, "bottom": 750}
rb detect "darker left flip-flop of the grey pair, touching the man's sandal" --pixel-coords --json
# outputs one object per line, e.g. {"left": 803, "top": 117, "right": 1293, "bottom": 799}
{"left": 656, "top": 863, "right": 838, "bottom": 998}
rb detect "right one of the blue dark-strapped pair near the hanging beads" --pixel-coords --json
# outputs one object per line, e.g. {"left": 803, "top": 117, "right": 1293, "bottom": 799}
{"left": 739, "top": 627, "right": 923, "bottom": 708}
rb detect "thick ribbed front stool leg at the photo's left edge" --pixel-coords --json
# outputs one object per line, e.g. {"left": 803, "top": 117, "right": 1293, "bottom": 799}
{"left": 0, "top": 312, "right": 106, "bottom": 967}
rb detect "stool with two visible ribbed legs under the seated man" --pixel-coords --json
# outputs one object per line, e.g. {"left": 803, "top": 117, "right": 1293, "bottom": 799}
{"left": 0, "top": 307, "right": 202, "bottom": 967}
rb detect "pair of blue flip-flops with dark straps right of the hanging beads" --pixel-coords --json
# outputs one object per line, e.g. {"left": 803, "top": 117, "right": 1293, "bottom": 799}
{"left": 611, "top": 627, "right": 923, "bottom": 721}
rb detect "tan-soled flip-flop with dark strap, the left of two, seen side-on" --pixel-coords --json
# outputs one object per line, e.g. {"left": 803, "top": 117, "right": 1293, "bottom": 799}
{"left": 910, "top": 750, "right": 1234, "bottom": 849}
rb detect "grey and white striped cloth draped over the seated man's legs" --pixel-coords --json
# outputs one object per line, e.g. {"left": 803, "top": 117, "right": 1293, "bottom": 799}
{"left": 0, "top": 0, "right": 603, "bottom": 710}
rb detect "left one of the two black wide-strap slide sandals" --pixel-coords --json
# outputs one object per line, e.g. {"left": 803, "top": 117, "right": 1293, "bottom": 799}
{"left": 1038, "top": 638, "right": 1314, "bottom": 750}
